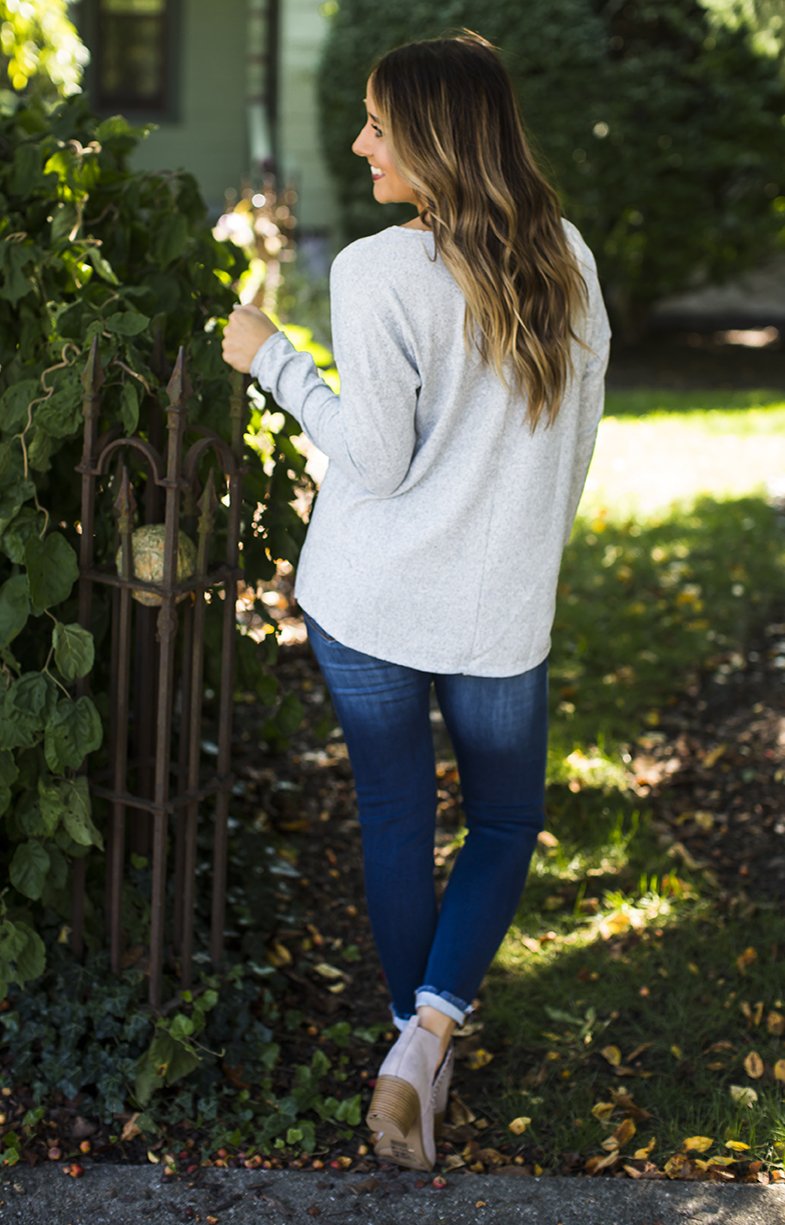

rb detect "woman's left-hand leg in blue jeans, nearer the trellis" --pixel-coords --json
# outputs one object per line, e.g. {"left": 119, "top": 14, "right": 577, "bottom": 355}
{"left": 305, "top": 615, "right": 436, "bottom": 1020}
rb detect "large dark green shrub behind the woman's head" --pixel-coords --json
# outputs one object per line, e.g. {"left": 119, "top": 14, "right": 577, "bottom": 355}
{"left": 320, "top": 0, "right": 785, "bottom": 327}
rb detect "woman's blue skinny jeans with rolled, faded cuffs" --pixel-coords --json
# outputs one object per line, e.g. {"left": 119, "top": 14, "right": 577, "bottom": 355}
{"left": 305, "top": 614, "right": 547, "bottom": 1025}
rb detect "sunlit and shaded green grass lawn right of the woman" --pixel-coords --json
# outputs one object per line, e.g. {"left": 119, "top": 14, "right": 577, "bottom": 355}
{"left": 473, "top": 391, "right": 785, "bottom": 1177}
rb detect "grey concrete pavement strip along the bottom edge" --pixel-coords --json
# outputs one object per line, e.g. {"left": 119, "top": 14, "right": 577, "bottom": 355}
{"left": 0, "top": 1165, "right": 785, "bottom": 1225}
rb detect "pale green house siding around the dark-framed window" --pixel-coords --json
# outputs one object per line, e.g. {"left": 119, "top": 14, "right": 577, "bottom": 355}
{"left": 72, "top": 0, "right": 336, "bottom": 233}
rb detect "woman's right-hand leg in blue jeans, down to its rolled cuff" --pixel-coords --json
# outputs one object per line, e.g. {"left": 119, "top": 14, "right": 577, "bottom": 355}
{"left": 416, "top": 663, "right": 547, "bottom": 1022}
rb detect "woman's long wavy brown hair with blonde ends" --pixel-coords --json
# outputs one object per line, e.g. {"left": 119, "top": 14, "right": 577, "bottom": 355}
{"left": 370, "top": 31, "right": 587, "bottom": 430}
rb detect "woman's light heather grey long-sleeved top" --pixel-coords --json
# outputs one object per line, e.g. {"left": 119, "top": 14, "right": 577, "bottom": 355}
{"left": 251, "top": 222, "right": 610, "bottom": 676}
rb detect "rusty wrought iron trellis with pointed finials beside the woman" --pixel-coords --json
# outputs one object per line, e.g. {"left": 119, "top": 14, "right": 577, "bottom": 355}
{"left": 71, "top": 341, "right": 244, "bottom": 1008}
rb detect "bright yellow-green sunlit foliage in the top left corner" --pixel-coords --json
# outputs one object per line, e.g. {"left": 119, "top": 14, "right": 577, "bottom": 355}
{"left": 0, "top": 0, "right": 89, "bottom": 99}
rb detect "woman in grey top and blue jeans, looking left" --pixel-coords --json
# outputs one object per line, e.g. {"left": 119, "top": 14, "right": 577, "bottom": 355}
{"left": 223, "top": 32, "right": 609, "bottom": 1169}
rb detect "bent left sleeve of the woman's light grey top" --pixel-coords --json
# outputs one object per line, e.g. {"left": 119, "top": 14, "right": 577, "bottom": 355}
{"left": 251, "top": 246, "right": 420, "bottom": 497}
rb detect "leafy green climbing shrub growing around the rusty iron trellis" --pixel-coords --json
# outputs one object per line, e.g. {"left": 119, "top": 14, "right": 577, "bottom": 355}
{"left": 0, "top": 97, "right": 304, "bottom": 998}
